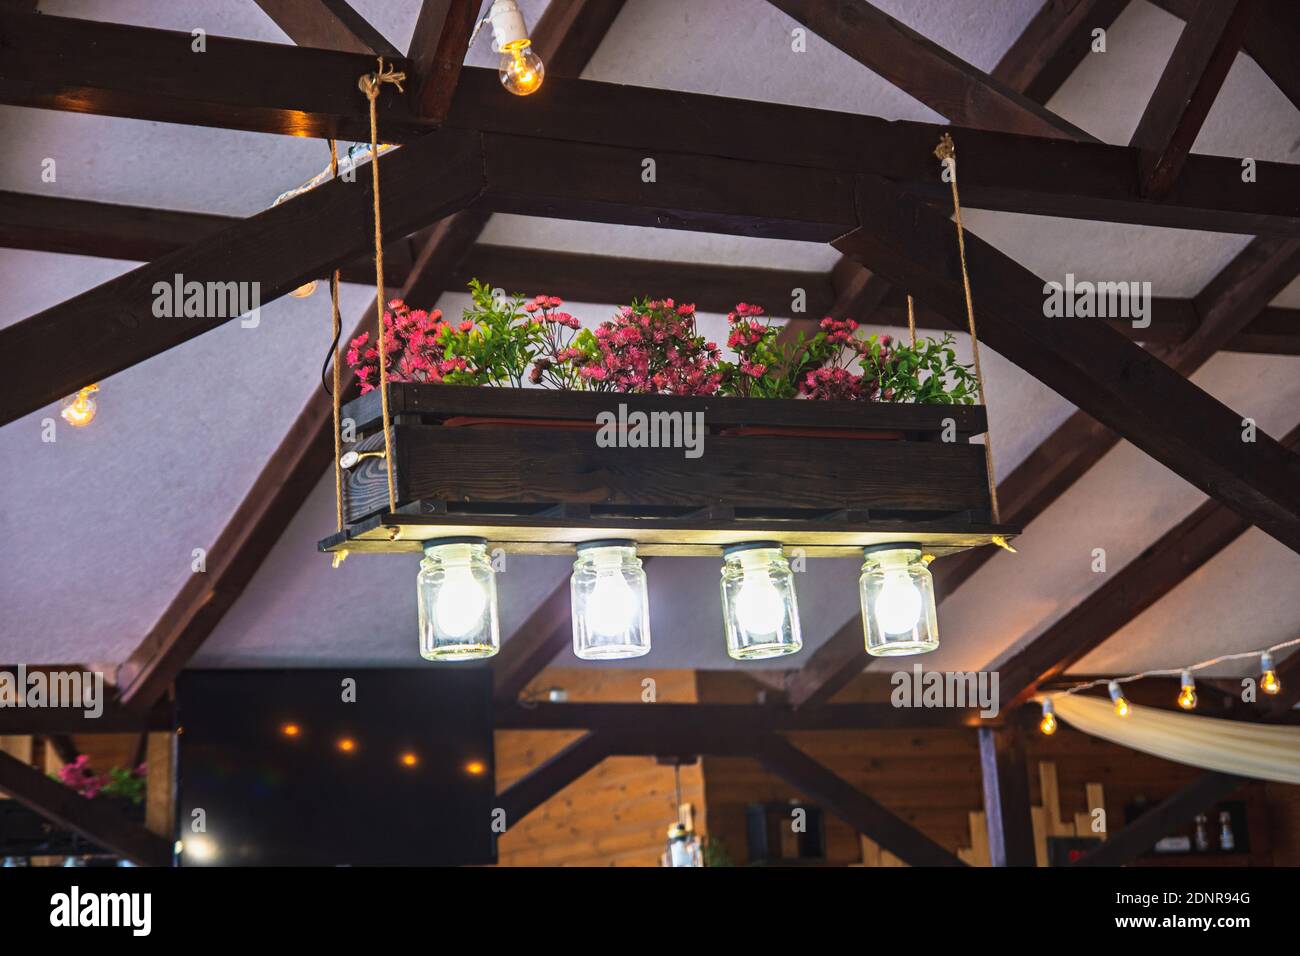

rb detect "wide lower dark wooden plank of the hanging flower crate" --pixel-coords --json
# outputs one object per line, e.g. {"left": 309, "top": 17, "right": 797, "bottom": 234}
{"left": 346, "top": 424, "right": 989, "bottom": 523}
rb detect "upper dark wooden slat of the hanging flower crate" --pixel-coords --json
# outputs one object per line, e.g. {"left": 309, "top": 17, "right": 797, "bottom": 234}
{"left": 342, "top": 382, "right": 988, "bottom": 441}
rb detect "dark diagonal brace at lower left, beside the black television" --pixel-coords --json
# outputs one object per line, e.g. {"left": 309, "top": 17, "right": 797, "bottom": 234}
{"left": 0, "top": 753, "right": 172, "bottom": 866}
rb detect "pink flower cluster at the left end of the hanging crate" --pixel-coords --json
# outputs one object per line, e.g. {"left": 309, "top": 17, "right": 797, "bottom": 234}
{"left": 347, "top": 299, "right": 473, "bottom": 395}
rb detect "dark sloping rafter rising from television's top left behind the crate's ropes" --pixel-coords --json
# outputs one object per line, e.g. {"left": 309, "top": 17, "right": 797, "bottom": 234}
{"left": 111, "top": 0, "right": 629, "bottom": 715}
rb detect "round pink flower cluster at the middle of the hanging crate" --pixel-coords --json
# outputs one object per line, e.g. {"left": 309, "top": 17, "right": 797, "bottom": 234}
{"left": 579, "top": 299, "right": 723, "bottom": 395}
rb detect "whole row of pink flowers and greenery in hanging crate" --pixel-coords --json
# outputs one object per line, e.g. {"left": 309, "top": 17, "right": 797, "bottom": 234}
{"left": 347, "top": 280, "right": 978, "bottom": 405}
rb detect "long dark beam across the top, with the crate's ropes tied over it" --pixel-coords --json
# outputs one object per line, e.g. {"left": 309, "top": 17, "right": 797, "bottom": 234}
{"left": 10, "top": 14, "right": 1300, "bottom": 235}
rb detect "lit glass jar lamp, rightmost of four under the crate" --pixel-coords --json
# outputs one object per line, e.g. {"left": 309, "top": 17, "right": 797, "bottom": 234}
{"left": 858, "top": 544, "right": 939, "bottom": 657}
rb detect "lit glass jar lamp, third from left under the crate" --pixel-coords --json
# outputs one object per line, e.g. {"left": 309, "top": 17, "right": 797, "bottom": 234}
{"left": 722, "top": 541, "right": 803, "bottom": 661}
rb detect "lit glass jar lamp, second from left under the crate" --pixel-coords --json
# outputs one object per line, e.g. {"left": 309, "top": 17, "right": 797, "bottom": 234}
{"left": 569, "top": 541, "right": 650, "bottom": 661}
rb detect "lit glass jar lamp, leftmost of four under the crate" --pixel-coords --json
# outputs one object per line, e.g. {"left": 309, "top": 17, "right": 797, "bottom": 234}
{"left": 417, "top": 537, "right": 501, "bottom": 661}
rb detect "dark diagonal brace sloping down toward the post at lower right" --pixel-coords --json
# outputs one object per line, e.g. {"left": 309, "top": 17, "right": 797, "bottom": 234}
{"left": 754, "top": 734, "right": 966, "bottom": 866}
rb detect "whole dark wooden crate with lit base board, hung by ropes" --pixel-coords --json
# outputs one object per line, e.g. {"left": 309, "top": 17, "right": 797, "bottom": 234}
{"left": 321, "top": 382, "right": 1011, "bottom": 557}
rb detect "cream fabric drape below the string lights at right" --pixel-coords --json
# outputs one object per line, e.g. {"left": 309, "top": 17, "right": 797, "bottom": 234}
{"left": 1052, "top": 693, "right": 1300, "bottom": 783}
